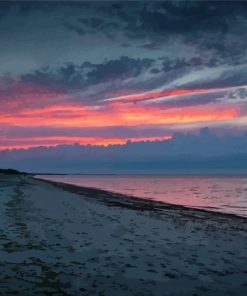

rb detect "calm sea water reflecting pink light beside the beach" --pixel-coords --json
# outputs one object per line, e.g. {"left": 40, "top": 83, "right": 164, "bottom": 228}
{"left": 37, "top": 175, "right": 247, "bottom": 217}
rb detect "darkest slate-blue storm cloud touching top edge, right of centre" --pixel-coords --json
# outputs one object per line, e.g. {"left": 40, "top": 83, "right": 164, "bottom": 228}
{"left": 132, "top": 1, "right": 233, "bottom": 38}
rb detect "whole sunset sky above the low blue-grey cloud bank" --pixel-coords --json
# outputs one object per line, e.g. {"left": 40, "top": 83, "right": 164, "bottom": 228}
{"left": 0, "top": 1, "right": 247, "bottom": 150}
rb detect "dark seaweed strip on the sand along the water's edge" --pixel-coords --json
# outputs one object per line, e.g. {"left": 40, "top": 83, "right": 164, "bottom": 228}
{"left": 36, "top": 177, "right": 247, "bottom": 223}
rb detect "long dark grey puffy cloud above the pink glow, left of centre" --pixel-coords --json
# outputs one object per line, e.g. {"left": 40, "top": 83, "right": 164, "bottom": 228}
{"left": 21, "top": 57, "right": 154, "bottom": 90}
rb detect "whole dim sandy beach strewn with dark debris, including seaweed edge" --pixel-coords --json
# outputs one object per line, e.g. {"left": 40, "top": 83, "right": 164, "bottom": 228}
{"left": 0, "top": 174, "right": 247, "bottom": 296}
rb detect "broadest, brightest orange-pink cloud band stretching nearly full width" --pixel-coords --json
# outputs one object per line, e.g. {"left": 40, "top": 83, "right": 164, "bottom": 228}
{"left": 0, "top": 105, "right": 238, "bottom": 127}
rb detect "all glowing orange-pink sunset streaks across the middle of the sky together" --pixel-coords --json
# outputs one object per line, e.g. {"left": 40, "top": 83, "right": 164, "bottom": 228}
{"left": 0, "top": 85, "right": 240, "bottom": 149}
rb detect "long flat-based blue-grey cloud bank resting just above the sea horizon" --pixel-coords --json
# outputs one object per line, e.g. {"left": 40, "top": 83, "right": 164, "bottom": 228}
{"left": 0, "top": 128, "right": 247, "bottom": 173}
